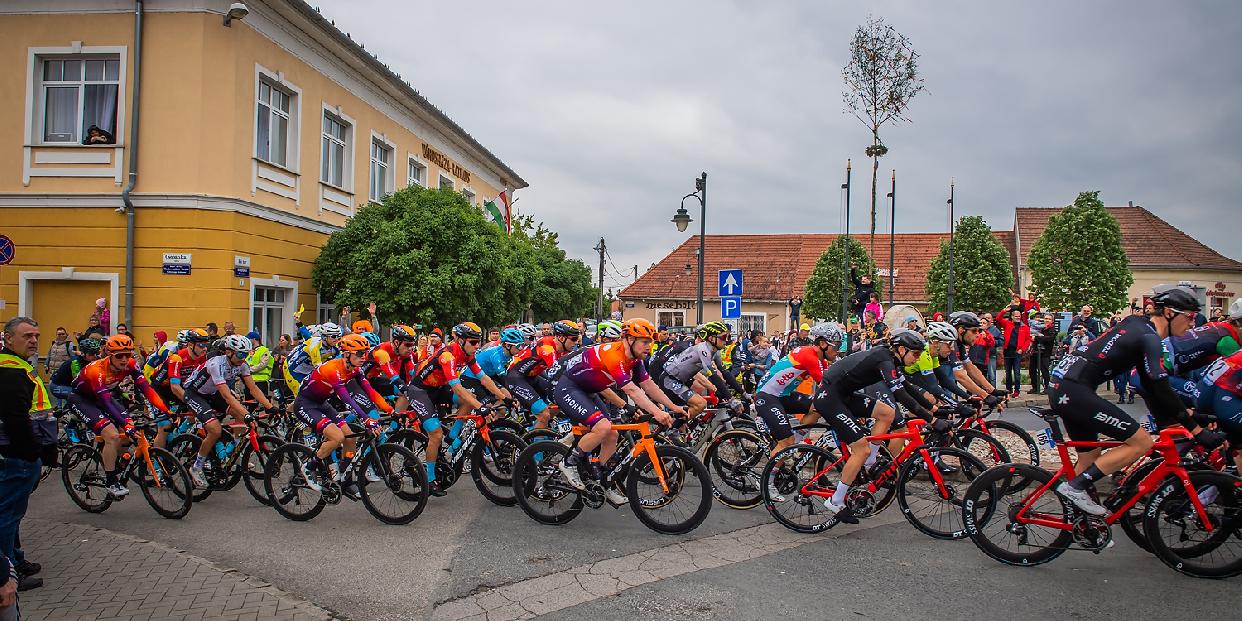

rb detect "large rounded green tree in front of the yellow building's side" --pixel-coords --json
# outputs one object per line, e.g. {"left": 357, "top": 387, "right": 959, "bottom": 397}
{"left": 311, "top": 185, "right": 544, "bottom": 325}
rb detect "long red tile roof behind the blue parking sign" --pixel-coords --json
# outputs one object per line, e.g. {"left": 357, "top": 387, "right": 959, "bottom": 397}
{"left": 620, "top": 231, "right": 1013, "bottom": 302}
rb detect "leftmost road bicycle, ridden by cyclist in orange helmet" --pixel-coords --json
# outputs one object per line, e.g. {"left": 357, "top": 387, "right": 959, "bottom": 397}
{"left": 61, "top": 421, "right": 194, "bottom": 519}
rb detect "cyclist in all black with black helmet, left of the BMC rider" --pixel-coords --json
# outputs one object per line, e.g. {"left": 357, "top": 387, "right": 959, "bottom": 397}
{"left": 814, "top": 329, "right": 927, "bottom": 523}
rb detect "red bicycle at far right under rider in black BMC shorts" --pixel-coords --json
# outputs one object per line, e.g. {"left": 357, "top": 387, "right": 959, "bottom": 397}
{"left": 961, "top": 409, "right": 1242, "bottom": 578}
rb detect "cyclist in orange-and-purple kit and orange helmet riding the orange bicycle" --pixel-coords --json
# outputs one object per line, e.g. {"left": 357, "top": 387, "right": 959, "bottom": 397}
{"left": 553, "top": 319, "right": 686, "bottom": 504}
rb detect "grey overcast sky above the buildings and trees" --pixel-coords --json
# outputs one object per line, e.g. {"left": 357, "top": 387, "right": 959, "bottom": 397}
{"left": 312, "top": 0, "right": 1242, "bottom": 291}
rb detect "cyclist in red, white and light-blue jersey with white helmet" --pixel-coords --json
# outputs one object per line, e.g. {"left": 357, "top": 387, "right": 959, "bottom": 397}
{"left": 755, "top": 323, "right": 845, "bottom": 455}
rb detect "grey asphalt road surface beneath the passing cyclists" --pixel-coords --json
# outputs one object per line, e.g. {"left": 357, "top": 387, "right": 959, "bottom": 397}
{"left": 27, "top": 399, "right": 1242, "bottom": 620}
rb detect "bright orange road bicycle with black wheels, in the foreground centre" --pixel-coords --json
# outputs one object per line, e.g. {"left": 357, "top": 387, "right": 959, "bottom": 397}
{"left": 513, "top": 416, "right": 712, "bottom": 534}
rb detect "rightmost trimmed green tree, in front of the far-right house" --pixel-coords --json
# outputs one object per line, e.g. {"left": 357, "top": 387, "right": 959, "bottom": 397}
{"left": 1027, "top": 191, "right": 1134, "bottom": 313}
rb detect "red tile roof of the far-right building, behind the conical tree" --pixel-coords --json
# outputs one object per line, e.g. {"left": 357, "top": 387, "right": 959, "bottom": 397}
{"left": 1013, "top": 206, "right": 1242, "bottom": 270}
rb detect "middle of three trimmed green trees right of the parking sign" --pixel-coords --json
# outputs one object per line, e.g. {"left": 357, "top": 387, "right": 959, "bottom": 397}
{"left": 925, "top": 216, "right": 1013, "bottom": 312}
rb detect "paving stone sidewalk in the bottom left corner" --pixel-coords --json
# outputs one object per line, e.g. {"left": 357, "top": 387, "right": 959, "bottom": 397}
{"left": 13, "top": 519, "right": 339, "bottom": 621}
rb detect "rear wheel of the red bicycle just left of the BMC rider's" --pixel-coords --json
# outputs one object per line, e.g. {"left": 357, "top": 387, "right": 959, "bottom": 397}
{"left": 760, "top": 443, "right": 840, "bottom": 533}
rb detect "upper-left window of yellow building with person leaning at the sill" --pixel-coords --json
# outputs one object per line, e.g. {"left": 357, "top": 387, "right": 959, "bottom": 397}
{"left": 39, "top": 55, "right": 120, "bottom": 144}
